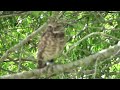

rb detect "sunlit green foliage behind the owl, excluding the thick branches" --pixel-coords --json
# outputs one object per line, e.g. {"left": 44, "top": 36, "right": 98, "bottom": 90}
{"left": 0, "top": 11, "right": 120, "bottom": 79}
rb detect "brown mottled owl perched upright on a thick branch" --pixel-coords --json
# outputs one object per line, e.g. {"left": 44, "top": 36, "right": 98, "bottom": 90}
{"left": 37, "top": 23, "right": 65, "bottom": 68}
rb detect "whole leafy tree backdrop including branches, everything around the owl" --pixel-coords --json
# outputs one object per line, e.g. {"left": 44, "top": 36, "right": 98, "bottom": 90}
{"left": 0, "top": 11, "right": 120, "bottom": 79}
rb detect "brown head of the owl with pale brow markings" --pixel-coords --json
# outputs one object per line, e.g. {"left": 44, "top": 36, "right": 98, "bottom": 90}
{"left": 48, "top": 23, "right": 64, "bottom": 33}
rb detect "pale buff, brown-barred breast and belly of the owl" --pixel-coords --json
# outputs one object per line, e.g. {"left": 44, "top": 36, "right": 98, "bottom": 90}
{"left": 42, "top": 35, "right": 65, "bottom": 61}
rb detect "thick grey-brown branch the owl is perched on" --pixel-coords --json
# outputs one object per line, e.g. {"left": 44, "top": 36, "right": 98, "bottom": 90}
{"left": 0, "top": 42, "right": 120, "bottom": 79}
